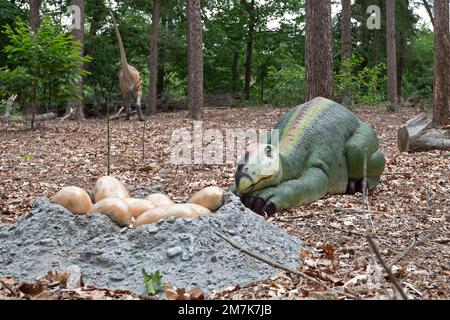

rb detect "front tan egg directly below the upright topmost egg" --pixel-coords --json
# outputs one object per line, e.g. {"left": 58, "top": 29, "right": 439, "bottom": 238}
{"left": 89, "top": 198, "right": 132, "bottom": 227}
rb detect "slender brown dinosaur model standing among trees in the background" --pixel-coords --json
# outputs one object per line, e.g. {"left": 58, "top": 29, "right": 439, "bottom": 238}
{"left": 110, "top": 12, "right": 145, "bottom": 121}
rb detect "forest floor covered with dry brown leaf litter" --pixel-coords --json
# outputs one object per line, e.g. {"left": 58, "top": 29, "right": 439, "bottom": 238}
{"left": 0, "top": 108, "right": 450, "bottom": 299}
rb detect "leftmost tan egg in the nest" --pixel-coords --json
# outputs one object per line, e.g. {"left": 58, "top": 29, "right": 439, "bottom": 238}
{"left": 52, "top": 186, "right": 92, "bottom": 214}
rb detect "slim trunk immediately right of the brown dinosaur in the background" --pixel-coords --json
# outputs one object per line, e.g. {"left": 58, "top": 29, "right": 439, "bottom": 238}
{"left": 147, "top": 0, "right": 160, "bottom": 114}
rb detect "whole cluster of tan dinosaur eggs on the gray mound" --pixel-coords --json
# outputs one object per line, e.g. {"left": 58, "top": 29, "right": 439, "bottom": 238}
{"left": 52, "top": 176, "right": 223, "bottom": 227}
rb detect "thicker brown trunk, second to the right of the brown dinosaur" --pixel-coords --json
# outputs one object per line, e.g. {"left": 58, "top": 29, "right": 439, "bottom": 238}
{"left": 187, "top": 0, "right": 203, "bottom": 120}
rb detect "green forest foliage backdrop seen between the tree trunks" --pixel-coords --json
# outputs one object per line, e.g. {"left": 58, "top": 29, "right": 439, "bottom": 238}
{"left": 0, "top": 0, "right": 440, "bottom": 115}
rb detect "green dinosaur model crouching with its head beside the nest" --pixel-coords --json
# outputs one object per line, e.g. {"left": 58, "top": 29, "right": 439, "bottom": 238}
{"left": 232, "top": 98, "right": 385, "bottom": 215}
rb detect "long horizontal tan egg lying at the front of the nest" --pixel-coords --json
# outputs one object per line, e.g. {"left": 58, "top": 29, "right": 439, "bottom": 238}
{"left": 135, "top": 204, "right": 204, "bottom": 227}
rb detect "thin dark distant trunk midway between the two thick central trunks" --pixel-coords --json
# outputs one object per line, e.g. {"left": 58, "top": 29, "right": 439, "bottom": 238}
{"left": 241, "top": 0, "right": 257, "bottom": 101}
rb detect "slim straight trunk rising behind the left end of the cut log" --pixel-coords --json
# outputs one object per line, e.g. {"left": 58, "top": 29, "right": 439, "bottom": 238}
{"left": 386, "top": 0, "right": 398, "bottom": 112}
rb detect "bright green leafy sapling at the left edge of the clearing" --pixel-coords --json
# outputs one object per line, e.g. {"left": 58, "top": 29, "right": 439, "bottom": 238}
{"left": 0, "top": 17, "right": 90, "bottom": 112}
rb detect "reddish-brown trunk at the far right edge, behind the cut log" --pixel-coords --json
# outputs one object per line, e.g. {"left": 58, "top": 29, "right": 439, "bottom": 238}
{"left": 433, "top": 0, "right": 450, "bottom": 126}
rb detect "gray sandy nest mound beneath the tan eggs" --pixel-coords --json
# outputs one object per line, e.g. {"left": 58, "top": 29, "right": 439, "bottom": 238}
{"left": 0, "top": 195, "right": 302, "bottom": 294}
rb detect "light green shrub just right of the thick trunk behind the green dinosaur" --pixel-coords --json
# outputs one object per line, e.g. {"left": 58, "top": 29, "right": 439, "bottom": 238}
{"left": 334, "top": 55, "right": 387, "bottom": 106}
